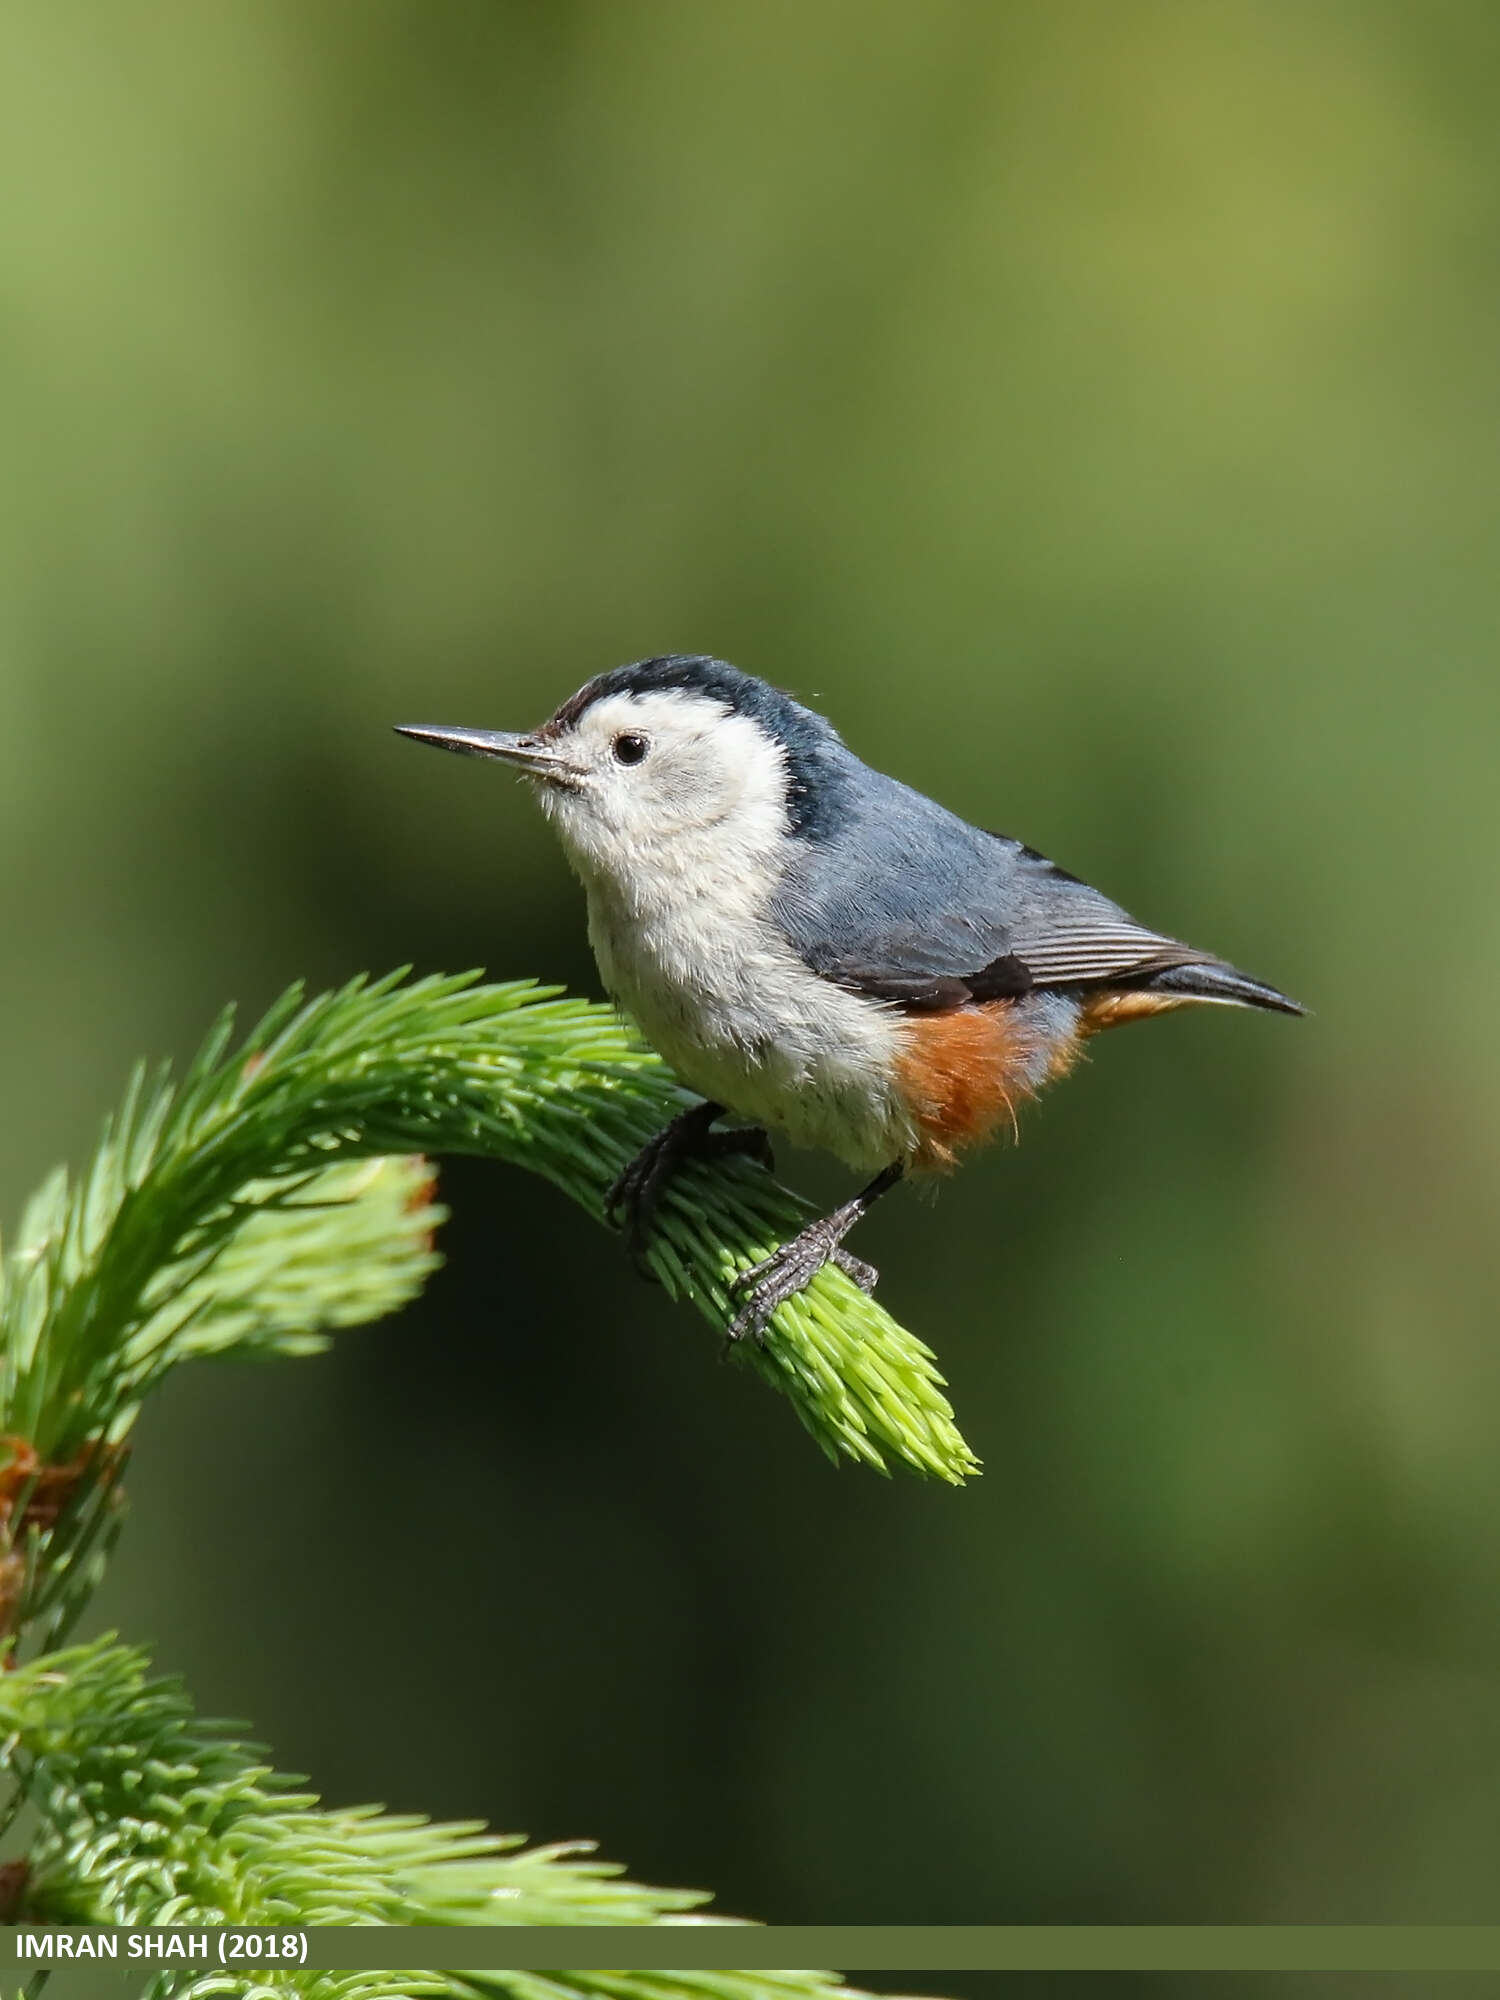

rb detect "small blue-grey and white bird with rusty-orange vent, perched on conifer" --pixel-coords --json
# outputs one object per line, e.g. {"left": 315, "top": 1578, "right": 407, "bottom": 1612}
{"left": 398, "top": 654, "right": 1304, "bottom": 1342}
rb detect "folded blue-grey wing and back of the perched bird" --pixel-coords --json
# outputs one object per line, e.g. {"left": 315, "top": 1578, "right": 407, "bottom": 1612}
{"left": 772, "top": 770, "right": 1206, "bottom": 1010}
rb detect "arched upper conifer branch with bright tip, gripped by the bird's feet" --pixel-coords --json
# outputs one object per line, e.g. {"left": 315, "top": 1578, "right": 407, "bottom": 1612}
{"left": 0, "top": 974, "right": 976, "bottom": 1484}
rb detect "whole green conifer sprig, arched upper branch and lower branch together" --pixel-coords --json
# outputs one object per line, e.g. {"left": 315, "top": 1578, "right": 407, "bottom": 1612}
{"left": 0, "top": 974, "right": 974, "bottom": 2000}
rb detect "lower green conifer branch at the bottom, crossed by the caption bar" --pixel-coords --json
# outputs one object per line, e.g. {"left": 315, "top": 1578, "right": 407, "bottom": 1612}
{"left": 0, "top": 1638, "right": 900, "bottom": 2000}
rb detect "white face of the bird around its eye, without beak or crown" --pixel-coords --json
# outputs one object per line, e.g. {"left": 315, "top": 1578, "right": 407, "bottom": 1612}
{"left": 528, "top": 688, "right": 788, "bottom": 888}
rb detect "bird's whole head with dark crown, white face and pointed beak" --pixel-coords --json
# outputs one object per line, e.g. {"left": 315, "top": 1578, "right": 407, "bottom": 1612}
{"left": 400, "top": 654, "right": 842, "bottom": 884}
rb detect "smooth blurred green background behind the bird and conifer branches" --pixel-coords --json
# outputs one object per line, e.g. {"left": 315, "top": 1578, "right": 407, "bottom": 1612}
{"left": 0, "top": 0, "right": 1500, "bottom": 1984}
